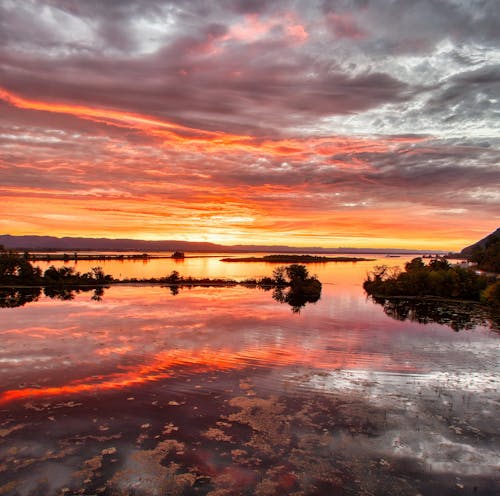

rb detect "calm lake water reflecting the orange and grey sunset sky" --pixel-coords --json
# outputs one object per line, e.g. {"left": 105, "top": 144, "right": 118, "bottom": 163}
{"left": 0, "top": 258, "right": 500, "bottom": 496}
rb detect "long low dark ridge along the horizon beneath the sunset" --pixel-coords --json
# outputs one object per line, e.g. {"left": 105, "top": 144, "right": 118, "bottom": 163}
{"left": 0, "top": 234, "right": 444, "bottom": 255}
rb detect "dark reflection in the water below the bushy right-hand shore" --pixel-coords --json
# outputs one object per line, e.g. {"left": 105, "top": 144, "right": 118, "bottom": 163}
{"left": 373, "top": 297, "right": 500, "bottom": 332}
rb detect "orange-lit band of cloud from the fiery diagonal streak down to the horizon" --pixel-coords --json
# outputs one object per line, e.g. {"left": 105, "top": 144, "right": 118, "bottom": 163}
{"left": 0, "top": 89, "right": 494, "bottom": 249}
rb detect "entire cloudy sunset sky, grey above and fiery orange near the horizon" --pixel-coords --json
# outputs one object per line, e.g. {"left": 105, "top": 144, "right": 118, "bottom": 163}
{"left": 0, "top": 0, "right": 500, "bottom": 250}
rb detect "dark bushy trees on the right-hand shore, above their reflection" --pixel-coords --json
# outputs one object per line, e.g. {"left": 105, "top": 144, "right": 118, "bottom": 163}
{"left": 363, "top": 258, "right": 500, "bottom": 305}
